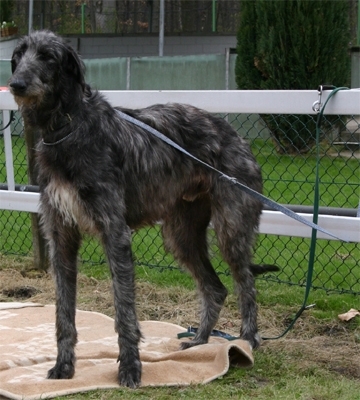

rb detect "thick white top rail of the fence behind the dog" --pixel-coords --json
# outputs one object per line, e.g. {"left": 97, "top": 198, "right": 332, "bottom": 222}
{"left": 0, "top": 89, "right": 360, "bottom": 115}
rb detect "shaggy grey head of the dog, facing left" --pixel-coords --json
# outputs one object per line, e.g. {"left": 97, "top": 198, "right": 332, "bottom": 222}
{"left": 9, "top": 30, "right": 86, "bottom": 105}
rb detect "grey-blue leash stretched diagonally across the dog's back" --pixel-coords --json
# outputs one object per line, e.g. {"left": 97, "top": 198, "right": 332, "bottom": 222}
{"left": 115, "top": 109, "right": 346, "bottom": 242}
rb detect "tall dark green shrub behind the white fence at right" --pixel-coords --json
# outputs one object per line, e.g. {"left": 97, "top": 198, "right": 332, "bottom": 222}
{"left": 235, "top": 0, "right": 350, "bottom": 153}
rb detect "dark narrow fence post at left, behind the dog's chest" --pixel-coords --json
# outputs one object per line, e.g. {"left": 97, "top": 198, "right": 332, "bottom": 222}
{"left": 24, "top": 121, "right": 49, "bottom": 271}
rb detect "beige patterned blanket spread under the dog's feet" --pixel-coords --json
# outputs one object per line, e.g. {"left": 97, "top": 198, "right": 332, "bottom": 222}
{"left": 0, "top": 303, "right": 253, "bottom": 400}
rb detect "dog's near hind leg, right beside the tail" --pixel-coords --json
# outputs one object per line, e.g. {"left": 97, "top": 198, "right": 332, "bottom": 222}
{"left": 212, "top": 184, "right": 261, "bottom": 348}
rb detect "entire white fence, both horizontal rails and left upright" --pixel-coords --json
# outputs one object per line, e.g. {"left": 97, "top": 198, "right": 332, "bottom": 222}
{"left": 0, "top": 89, "right": 360, "bottom": 242}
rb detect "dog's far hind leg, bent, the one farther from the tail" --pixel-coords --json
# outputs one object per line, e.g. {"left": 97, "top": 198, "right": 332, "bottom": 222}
{"left": 162, "top": 197, "right": 227, "bottom": 349}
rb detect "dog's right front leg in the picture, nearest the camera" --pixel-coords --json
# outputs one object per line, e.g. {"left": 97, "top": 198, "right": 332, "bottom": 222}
{"left": 103, "top": 222, "right": 141, "bottom": 388}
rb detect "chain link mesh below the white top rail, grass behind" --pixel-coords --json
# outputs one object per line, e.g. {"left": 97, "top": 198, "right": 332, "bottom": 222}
{"left": 0, "top": 112, "right": 360, "bottom": 294}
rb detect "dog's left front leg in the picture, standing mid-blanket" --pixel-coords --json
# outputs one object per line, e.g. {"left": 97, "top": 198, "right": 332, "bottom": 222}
{"left": 47, "top": 221, "right": 81, "bottom": 379}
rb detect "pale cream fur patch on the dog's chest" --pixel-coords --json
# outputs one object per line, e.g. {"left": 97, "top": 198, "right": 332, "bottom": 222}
{"left": 45, "top": 180, "right": 94, "bottom": 231}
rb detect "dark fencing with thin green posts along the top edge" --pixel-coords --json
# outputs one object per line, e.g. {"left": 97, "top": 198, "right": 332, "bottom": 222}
{"left": 13, "top": 0, "right": 240, "bottom": 35}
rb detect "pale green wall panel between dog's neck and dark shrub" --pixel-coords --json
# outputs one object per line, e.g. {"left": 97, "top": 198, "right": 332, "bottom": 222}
{"left": 84, "top": 54, "right": 236, "bottom": 90}
